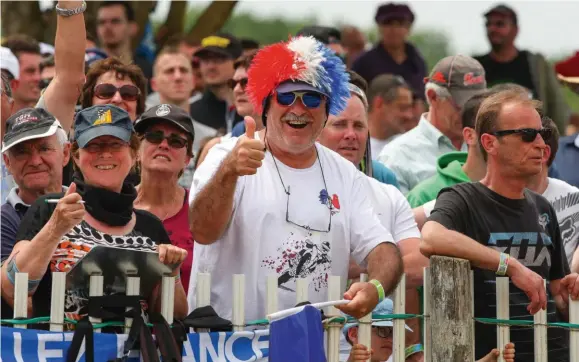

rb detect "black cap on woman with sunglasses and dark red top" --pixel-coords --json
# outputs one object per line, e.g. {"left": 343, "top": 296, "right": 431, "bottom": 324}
{"left": 135, "top": 104, "right": 195, "bottom": 140}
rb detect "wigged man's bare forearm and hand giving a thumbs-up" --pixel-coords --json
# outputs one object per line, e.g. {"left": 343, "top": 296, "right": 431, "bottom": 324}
{"left": 189, "top": 117, "right": 265, "bottom": 245}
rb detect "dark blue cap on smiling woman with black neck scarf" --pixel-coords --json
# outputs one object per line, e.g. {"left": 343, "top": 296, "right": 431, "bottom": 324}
{"left": 74, "top": 104, "right": 135, "bottom": 148}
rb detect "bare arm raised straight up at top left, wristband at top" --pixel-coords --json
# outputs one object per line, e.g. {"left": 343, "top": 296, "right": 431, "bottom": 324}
{"left": 43, "top": 1, "right": 86, "bottom": 132}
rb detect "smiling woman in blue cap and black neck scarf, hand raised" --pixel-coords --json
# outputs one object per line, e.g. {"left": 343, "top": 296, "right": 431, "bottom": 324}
{"left": 1, "top": 105, "right": 187, "bottom": 326}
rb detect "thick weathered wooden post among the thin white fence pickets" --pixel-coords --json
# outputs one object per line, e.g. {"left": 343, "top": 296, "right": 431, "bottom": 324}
{"left": 425, "top": 256, "right": 474, "bottom": 362}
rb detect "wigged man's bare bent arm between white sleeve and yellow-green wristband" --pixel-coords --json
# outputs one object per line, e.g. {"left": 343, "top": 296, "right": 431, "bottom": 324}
{"left": 366, "top": 243, "right": 404, "bottom": 295}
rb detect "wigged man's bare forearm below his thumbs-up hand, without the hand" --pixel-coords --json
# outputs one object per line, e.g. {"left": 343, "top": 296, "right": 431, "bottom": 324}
{"left": 189, "top": 154, "right": 239, "bottom": 245}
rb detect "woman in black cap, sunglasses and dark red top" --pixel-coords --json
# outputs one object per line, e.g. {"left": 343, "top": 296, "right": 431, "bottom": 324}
{"left": 135, "top": 104, "right": 195, "bottom": 291}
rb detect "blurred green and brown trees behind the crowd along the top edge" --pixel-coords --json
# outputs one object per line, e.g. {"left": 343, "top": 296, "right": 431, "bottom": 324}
{"left": 1, "top": 1, "right": 579, "bottom": 112}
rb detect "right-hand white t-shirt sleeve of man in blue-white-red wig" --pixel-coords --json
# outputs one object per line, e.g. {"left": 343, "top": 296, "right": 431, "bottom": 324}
{"left": 349, "top": 171, "right": 394, "bottom": 267}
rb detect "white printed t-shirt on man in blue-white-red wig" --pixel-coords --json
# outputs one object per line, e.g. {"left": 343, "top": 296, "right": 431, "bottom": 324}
{"left": 187, "top": 137, "right": 393, "bottom": 320}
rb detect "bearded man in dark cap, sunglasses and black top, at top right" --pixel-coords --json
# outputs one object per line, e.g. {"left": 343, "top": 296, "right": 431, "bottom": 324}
{"left": 475, "top": 5, "right": 570, "bottom": 134}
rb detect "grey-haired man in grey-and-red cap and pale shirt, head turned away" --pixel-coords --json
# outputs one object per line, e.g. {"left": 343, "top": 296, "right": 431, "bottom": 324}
{"left": 378, "top": 55, "right": 487, "bottom": 193}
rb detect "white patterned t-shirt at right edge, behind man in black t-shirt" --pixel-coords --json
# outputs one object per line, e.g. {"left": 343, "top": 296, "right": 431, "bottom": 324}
{"left": 543, "top": 177, "right": 579, "bottom": 265}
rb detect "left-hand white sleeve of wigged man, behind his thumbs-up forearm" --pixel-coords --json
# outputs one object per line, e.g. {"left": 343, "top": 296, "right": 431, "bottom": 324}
{"left": 189, "top": 138, "right": 243, "bottom": 209}
